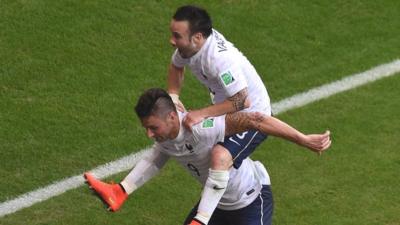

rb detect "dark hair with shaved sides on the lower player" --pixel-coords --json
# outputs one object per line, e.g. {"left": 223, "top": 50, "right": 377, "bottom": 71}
{"left": 135, "top": 88, "right": 176, "bottom": 119}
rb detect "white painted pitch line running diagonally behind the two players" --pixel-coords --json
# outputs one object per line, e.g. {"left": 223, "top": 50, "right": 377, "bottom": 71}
{"left": 0, "top": 60, "right": 400, "bottom": 217}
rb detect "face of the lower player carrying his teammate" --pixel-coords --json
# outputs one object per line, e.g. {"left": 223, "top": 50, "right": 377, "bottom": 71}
{"left": 142, "top": 115, "right": 173, "bottom": 142}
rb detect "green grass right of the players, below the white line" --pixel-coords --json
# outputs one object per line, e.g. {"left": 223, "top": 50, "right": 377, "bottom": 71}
{"left": 257, "top": 75, "right": 400, "bottom": 224}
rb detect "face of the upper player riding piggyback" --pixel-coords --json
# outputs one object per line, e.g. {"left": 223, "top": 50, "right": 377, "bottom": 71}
{"left": 169, "top": 20, "right": 198, "bottom": 58}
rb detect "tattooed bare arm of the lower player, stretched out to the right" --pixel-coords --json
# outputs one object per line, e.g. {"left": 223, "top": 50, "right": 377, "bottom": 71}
{"left": 225, "top": 112, "right": 331, "bottom": 153}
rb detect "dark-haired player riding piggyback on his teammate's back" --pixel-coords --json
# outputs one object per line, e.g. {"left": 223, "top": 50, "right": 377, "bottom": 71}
{"left": 168, "top": 5, "right": 329, "bottom": 174}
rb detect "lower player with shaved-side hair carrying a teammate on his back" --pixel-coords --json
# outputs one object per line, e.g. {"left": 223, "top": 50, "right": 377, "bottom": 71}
{"left": 85, "top": 89, "right": 331, "bottom": 225}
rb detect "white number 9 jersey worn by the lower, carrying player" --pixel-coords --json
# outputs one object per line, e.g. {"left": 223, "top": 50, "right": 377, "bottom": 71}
{"left": 154, "top": 112, "right": 270, "bottom": 210}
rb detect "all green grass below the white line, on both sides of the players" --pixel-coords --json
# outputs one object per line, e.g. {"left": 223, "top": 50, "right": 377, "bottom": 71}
{"left": 0, "top": 71, "right": 400, "bottom": 225}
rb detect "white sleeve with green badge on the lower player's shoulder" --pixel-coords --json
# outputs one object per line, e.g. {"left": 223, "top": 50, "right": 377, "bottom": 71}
{"left": 192, "top": 115, "right": 225, "bottom": 146}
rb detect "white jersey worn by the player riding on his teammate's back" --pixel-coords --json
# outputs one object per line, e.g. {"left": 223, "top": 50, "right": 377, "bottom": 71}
{"left": 172, "top": 29, "right": 271, "bottom": 115}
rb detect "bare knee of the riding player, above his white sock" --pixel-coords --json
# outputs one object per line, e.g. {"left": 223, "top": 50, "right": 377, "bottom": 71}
{"left": 211, "top": 145, "right": 233, "bottom": 170}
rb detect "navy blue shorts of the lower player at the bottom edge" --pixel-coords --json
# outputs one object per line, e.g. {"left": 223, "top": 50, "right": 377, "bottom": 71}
{"left": 184, "top": 185, "right": 274, "bottom": 225}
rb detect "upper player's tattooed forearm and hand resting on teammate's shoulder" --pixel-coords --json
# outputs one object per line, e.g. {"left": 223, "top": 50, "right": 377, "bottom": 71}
{"left": 183, "top": 88, "right": 250, "bottom": 129}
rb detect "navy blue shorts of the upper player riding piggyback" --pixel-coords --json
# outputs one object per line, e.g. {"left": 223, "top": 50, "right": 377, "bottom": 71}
{"left": 218, "top": 130, "right": 268, "bottom": 169}
